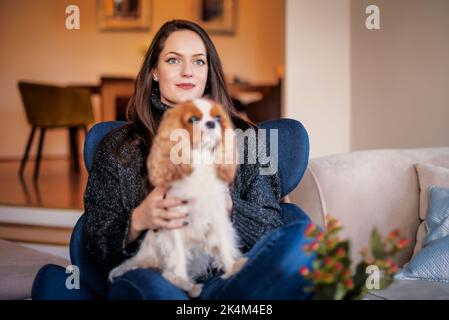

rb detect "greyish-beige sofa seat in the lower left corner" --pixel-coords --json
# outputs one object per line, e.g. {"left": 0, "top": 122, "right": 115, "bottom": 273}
{"left": 0, "top": 239, "right": 70, "bottom": 300}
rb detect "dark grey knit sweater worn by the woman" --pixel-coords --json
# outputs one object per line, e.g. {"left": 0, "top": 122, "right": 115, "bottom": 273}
{"left": 84, "top": 126, "right": 283, "bottom": 271}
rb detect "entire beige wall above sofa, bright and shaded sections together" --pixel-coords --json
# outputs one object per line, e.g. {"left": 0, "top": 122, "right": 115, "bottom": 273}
{"left": 285, "top": 0, "right": 449, "bottom": 157}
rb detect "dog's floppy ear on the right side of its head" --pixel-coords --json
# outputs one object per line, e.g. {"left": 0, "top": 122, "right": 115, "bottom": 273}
{"left": 214, "top": 104, "right": 238, "bottom": 183}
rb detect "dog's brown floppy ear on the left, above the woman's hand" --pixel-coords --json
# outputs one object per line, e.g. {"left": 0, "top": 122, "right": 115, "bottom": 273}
{"left": 147, "top": 107, "right": 192, "bottom": 186}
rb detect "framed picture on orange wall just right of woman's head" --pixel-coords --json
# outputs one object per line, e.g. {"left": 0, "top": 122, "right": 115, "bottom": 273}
{"left": 194, "top": 0, "right": 237, "bottom": 35}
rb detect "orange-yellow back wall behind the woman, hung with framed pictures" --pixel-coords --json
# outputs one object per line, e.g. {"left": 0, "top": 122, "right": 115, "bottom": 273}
{"left": 0, "top": 0, "right": 284, "bottom": 159}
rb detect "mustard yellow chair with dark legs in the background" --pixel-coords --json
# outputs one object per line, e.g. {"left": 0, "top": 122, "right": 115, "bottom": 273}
{"left": 19, "top": 81, "right": 94, "bottom": 180}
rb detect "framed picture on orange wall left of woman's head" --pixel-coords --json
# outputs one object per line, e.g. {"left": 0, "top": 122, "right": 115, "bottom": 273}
{"left": 97, "top": 0, "right": 151, "bottom": 31}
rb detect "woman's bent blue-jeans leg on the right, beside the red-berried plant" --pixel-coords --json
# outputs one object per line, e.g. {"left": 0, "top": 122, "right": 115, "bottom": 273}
{"left": 201, "top": 221, "right": 315, "bottom": 300}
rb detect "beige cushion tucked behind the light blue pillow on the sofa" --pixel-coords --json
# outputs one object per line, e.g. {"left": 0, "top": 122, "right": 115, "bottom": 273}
{"left": 413, "top": 163, "right": 449, "bottom": 256}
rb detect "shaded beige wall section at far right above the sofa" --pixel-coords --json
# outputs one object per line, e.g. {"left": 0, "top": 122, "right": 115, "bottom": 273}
{"left": 351, "top": 0, "right": 449, "bottom": 150}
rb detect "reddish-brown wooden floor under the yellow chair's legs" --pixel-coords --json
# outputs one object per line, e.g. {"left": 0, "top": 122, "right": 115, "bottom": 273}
{"left": 0, "top": 159, "right": 87, "bottom": 210}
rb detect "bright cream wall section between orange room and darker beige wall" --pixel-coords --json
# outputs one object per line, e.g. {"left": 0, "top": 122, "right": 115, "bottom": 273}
{"left": 284, "top": 0, "right": 351, "bottom": 157}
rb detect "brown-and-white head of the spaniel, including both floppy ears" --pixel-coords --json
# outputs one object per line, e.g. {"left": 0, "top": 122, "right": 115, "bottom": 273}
{"left": 148, "top": 99, "right": 236, "bottom": 185}
